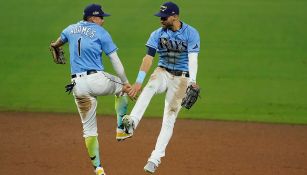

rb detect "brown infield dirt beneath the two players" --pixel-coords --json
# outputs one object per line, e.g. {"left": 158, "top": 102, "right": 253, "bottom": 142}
{"left": 0, "top": 112, "right": 307, "bottom": 175}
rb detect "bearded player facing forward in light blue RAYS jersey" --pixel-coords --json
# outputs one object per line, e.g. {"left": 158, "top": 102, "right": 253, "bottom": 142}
{"left": 123, "top": 2, "right": 200, "bottom": 173}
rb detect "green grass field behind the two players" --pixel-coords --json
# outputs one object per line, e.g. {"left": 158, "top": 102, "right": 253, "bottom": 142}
{"left": 0, "top": 0, "right": 307, "bottom": 124}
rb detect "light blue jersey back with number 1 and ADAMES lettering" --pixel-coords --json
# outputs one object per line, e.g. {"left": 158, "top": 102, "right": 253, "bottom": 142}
{"left": 61, "top": 21, "right": 117, "bottom": 74}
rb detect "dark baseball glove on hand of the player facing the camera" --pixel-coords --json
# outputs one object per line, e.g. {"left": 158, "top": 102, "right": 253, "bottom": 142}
{"left": 181, "top": 85, "right": 200, "bottom": 109}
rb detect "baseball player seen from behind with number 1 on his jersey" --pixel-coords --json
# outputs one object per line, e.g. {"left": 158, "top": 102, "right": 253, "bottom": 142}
{"left": 51, "top": 4, "right": 131, "bottom": 175}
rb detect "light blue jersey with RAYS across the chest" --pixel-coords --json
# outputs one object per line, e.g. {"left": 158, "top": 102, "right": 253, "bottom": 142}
{"left": 146, "top": 22, "right": 200, "bottom": 71}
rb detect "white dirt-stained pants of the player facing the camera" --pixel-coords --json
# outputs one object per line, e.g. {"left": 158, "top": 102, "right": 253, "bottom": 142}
{"left": 130, "top": 67, "right": 188, "bottom": 165}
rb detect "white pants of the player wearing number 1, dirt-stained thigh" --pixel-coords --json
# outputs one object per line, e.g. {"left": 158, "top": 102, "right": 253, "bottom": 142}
{"left": 72, "top": 71, "right": 123, "bottom": 138}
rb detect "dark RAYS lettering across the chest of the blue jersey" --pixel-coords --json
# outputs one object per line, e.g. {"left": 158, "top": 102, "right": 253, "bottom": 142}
{"left": 159, "top": 38, "right": 188, "bottom": 52}
